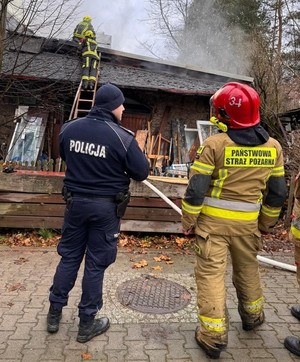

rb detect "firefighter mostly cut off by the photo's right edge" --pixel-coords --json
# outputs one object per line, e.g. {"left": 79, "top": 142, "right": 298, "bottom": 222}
{"left": 284, "top": 172, "right": 300, "bottom": 356}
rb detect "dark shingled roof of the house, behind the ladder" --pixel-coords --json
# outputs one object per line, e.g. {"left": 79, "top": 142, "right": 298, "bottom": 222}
{"left": 2, "top": 36, "right": 253, "bottom": 95}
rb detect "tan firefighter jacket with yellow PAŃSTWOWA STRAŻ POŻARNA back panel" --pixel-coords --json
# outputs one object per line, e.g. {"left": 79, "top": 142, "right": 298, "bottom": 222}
{"left": 182, "top": 133, "right": 286, "bottom": 236}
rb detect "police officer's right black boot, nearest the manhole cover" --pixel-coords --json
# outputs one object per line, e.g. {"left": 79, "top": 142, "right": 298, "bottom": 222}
{"left": 77, "top": 317, "right": 110, "bottom": 343}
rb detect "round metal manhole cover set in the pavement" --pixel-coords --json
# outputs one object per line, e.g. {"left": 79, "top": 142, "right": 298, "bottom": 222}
{"left": 117, "top": 275, "right": 191, "bottom": 314}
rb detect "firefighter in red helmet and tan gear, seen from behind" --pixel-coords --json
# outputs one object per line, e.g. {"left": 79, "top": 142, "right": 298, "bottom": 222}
{"left": 182, "top": 82, "right": 287, "bottom": 359}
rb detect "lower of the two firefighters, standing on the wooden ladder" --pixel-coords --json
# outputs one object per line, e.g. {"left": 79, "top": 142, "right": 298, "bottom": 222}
{"left": 81, "top": 30, "right": 100, "bottom": 89}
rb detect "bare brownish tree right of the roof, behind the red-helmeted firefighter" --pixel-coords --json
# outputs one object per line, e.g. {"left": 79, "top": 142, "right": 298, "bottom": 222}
{"left": 250, "top": 0, "right": 300, "bottom": 141}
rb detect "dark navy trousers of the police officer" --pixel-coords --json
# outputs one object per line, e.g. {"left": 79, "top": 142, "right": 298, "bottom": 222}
{"left": 49, "top": 196, "right": 120, "bottom": 321}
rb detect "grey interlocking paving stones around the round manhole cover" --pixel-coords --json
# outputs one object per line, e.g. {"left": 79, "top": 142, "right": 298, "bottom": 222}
{"left": 0, "top": 246, "right": 300, "bottom": 362}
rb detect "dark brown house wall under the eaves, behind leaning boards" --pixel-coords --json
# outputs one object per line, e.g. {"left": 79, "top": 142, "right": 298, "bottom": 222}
{"left": 0, "top": 89, "right": 209, "bottom": 164}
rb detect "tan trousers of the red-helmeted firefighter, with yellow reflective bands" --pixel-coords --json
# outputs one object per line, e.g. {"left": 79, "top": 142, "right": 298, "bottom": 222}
{"left": 195, "top": 231, "right": 264, "bottom": 347}
